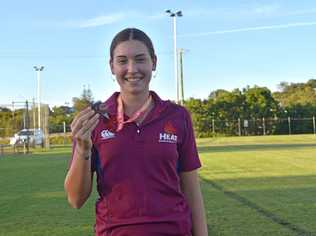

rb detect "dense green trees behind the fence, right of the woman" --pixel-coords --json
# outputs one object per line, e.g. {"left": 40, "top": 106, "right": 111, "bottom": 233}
{"left": 184, "top": 79, "right": 316, "bottom": 137}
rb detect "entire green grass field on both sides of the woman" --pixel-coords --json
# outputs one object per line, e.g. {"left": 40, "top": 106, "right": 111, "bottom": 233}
{"left": 0, "top": 135, "right": 316, "bottom": 236}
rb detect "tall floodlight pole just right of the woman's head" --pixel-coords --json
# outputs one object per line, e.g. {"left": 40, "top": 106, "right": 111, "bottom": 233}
{"left": 166, "top": 10, "right": 183, "bottom": 103}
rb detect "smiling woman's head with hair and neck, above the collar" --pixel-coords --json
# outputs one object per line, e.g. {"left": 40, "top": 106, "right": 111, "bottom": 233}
{"left": 110, "top": 30, "right": 157, "bottom": 100}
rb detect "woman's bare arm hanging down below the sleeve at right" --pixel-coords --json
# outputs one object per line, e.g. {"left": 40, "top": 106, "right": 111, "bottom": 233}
{"left": 180, "top": 170, "right": 208, "bottom": 236}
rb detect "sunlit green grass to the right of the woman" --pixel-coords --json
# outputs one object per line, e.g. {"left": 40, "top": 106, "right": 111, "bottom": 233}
{"left": 198, "top": 135, "right": 316, "bottom": 235}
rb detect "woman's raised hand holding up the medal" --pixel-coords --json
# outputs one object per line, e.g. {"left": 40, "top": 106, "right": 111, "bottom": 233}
{"left": 71, "top": 106, "right": 100, "bottom": 157}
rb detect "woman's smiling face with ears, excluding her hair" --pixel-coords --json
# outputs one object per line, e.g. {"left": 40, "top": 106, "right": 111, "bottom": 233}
{"left": 110, "top": 40, "right": 156, "bottom": 94}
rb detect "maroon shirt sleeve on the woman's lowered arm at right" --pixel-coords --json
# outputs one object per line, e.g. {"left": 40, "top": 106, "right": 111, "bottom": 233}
{"left": 178, "top": 108, "right": 201, "bottom": 172}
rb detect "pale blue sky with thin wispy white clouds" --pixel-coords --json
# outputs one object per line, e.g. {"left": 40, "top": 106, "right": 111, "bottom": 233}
{"left": 0, "top": 0, "right": 316, "bottom": 106}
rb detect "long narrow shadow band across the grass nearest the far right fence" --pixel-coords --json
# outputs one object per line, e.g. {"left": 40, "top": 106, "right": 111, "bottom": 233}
{"left": 198, "top": 143, "right": 316, "bottom": 153}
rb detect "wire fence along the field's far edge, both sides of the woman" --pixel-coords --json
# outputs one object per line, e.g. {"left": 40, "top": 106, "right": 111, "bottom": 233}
{"left": 0, "top": 101, "right": 316, "bottom": 148}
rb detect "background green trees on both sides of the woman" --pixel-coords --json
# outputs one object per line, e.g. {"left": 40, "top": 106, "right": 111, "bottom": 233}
{"left": 0, "top": 79, "right": 316, "bottom": 137}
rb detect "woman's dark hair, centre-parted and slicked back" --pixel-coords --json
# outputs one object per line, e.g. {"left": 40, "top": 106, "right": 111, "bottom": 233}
{"left": 110, "top": 28, "right": 156, "bottom": 61}
